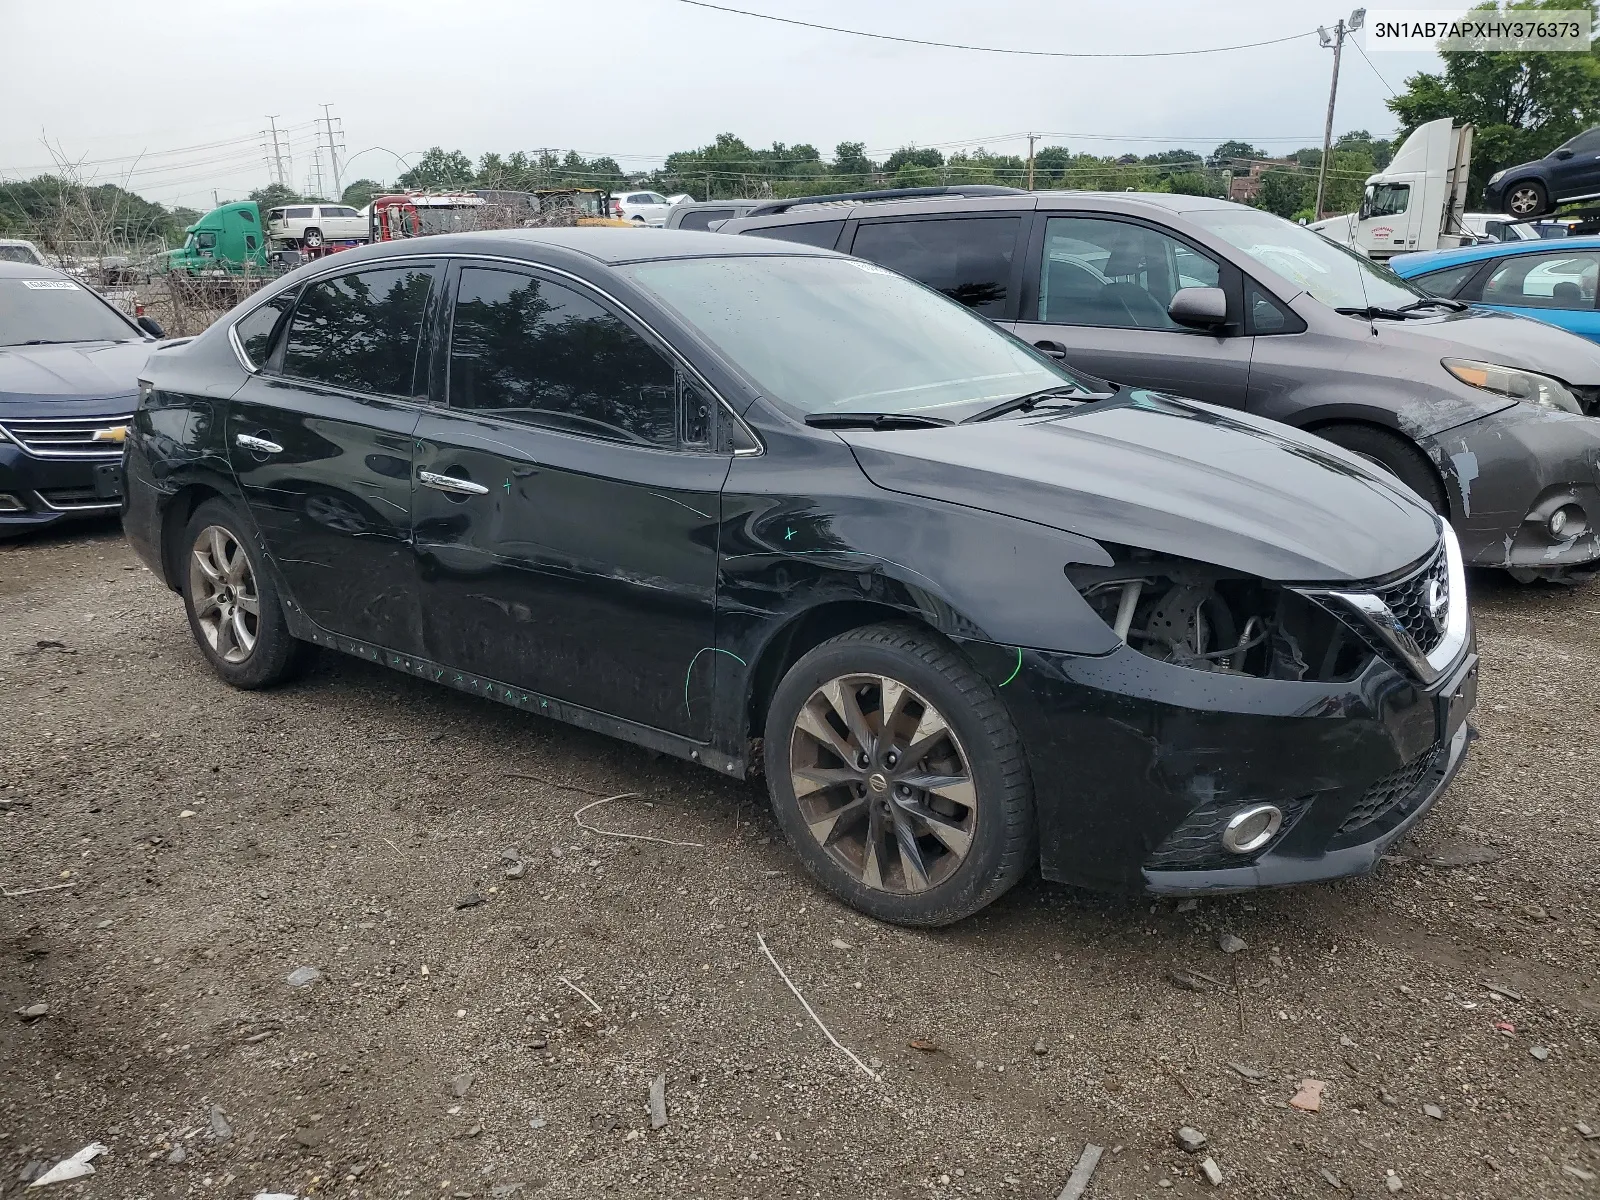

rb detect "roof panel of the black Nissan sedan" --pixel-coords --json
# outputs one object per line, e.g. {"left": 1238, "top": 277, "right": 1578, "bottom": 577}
{"left": 318, "top": 227, "right": 845, "bottom": 274}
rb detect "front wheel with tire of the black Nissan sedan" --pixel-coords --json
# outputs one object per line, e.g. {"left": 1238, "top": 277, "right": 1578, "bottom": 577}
{"left": 766, "top": 624, "right": 1037, "bottom": 926}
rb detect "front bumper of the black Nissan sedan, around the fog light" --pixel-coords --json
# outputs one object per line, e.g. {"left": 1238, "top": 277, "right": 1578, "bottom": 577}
{"left": 995, "top": 640, "right": 1477, "bottom": 894}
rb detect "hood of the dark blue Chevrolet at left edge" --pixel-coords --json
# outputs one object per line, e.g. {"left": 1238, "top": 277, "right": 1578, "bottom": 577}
{"left": 0, "top": 341, "right": 160, "bottom": 416}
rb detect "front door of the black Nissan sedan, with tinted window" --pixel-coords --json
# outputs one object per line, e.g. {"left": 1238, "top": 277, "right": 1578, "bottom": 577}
{"left": 414, "top": 262, "right": 731, "bottom": 741}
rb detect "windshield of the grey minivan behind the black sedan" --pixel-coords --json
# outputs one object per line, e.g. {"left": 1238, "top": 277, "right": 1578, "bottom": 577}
{"left": 1189, "top": 208, "right": 1427, "bottom": 309}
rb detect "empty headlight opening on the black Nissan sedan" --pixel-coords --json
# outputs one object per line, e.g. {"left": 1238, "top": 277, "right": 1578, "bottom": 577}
{"left": 1066, "top": 547, "right": 1373, "bottom": 683}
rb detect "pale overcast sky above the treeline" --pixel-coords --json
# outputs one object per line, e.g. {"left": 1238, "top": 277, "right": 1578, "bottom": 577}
{"left": 0, "top": 0, "right": 1464, "bottom": 208}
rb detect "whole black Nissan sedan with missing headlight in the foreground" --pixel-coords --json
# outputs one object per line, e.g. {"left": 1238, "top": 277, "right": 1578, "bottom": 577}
{"left": 125, "top": 229, "right": 1477, "bottom": 925}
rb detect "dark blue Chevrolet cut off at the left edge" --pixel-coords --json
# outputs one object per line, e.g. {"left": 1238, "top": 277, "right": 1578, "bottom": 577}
{"left": 0, "top": 262, "right": 162, "bottom": 538}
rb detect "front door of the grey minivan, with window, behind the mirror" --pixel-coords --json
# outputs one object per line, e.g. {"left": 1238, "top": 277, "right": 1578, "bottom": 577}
{"left": 1011, "top": 213, "right": 1253, "bottom": 408}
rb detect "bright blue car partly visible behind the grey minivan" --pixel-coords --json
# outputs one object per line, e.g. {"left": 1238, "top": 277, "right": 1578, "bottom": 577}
{"left": 1389, "top": 237, "right": 1600, "bottom": 342}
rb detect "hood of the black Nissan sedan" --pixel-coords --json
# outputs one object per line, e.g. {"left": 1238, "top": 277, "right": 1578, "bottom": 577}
{"left": 840, "top": 392, "right": 1438, "bottom": 582}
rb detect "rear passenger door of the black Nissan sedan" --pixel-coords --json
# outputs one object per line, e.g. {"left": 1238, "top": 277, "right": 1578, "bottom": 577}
{"left": 227, "top": 261, "right": 443, "bottom": 653}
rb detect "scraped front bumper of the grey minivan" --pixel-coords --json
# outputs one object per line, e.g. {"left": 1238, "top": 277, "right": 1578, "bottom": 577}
{"left": 1421, "top": 403, "right": 1600, "bottom": 573}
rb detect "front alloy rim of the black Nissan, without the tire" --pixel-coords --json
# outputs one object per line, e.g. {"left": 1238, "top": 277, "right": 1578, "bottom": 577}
{"left": 789, "top": 674, "right": 978, "bottom": 894}
